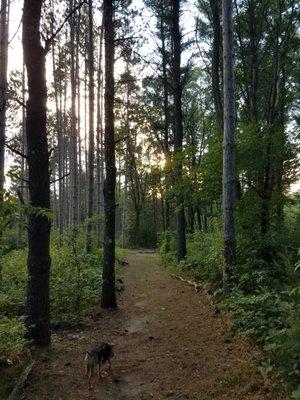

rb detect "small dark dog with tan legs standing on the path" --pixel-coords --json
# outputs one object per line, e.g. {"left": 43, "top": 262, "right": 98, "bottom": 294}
{"left": 84, "top": 343, "right": 115, "bottom": 389}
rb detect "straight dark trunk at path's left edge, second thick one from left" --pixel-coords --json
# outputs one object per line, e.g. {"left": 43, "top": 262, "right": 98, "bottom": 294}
{"left": 101, "top": 0, "right": 117, "bottom": 308}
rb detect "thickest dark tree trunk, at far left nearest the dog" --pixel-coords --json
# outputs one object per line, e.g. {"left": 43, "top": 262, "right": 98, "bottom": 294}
{"left": 23, "top": 0, "right": 51, "bottom": 346}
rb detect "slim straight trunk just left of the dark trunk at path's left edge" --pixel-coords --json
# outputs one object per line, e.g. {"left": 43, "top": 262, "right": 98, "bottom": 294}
{"left": 86, "top": 0, "right": 95, "bottom": 253}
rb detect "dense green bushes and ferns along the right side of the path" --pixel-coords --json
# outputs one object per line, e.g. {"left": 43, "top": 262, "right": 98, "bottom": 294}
{"left": 160, "top": 202, "right": 300, "bottom": 390}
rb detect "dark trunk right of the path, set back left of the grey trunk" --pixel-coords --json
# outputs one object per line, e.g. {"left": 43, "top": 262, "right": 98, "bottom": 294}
{"left": 172, "top": 0, "right": 186, "bottom": 261}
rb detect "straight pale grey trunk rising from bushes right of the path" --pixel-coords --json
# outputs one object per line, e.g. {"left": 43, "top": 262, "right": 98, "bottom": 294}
{"left": 222, "top": 0, "right": 235, "bottom": 292}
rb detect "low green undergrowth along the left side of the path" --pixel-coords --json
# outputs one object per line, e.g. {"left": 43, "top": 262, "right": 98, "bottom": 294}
{"left": 0, "top": 230, "right": 122, "bottom": 362}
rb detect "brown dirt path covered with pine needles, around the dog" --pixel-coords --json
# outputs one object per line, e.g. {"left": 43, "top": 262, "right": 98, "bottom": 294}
{"left": 21, "top": 251, "right": 285, "bottom": 400}
